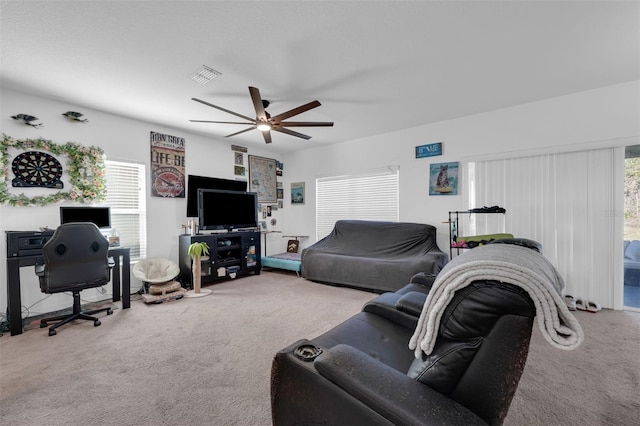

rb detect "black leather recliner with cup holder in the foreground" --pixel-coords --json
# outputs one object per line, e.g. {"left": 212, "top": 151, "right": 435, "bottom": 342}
{"left": 271, "top": 238, "right": 536, "bottom": 426}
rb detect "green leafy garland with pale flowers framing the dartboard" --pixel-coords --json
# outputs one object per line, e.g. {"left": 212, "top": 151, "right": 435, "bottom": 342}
{"left": 0, "top": 133, "right": 107, "bottom": 206}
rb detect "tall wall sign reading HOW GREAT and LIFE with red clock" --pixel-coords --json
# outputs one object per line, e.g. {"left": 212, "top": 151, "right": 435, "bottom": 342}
{"left": 151, "top": 132, "right": 185, "bottom": 198}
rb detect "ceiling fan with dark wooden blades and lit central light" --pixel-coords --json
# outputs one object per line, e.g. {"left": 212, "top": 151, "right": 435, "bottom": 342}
{"left": 189, "top": 86, "right": 333, "bottom": 143}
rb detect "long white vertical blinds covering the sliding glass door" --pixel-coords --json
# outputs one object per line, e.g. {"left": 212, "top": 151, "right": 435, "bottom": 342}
{"left": 467, "top": 147, "right": 624, "bottom": 309}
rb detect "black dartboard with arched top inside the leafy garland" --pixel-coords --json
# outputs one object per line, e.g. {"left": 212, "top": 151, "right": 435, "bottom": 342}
{"left": 11, "top": 151, "right": 63, "bottom": 189}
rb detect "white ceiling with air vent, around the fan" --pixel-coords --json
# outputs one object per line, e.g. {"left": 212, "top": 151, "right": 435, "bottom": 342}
{"left": 0, "top": 0, "right": 640, "bottom": 152}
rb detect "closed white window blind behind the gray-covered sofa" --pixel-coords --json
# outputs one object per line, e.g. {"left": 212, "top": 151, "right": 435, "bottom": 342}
{"left": 316, "top": 166, "right": 399, "bottom": 240}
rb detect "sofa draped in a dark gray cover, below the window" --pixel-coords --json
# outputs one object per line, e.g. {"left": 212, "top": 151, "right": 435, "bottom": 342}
{"left": 302, "top": 220, "right": 449, "bottom": 293}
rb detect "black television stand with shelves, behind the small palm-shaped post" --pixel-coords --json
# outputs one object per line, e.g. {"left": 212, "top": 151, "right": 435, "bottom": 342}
{"left": 178, "top": 231, "right": 262, "bottom": 288}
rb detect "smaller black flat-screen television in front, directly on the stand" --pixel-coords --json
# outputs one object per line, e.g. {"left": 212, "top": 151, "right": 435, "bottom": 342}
{"left": 198, "top": 189, "right": 258, "bottom": 231}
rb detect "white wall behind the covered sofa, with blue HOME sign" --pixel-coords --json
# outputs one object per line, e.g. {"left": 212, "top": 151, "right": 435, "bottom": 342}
{"left": 284, "top": 81, "right": 640, "bottom": 251}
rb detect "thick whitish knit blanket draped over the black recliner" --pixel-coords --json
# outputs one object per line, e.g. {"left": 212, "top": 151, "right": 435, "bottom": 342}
{"left": 409, "top": 244, "right": 584, "bottom": 358}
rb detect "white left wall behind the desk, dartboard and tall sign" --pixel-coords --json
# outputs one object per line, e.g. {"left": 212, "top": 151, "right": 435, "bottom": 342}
{"left": 0, "top": 88, "right": 280, "bottom": 315}
